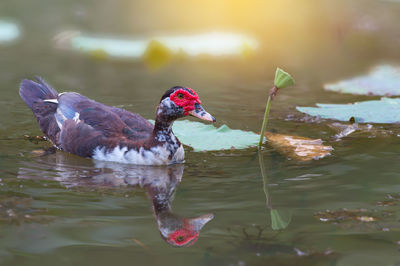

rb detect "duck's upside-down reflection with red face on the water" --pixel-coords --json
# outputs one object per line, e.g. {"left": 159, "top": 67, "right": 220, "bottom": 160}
{"left": 18, "top": 152, "right": 214, "bottom": 247}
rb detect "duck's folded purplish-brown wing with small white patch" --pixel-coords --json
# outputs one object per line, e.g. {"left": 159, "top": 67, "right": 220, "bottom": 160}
{"left": 55, "top": 93, "right": 152, "bottom": 157}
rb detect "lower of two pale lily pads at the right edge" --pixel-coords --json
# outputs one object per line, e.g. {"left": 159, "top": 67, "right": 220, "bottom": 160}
{"left": 296, "top": 98, "right": 400, "bottom": 124}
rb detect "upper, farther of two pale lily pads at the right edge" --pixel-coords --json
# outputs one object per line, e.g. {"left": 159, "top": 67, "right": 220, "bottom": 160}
{"left": 324, "top": 65, "right": 400, "bottom": 96}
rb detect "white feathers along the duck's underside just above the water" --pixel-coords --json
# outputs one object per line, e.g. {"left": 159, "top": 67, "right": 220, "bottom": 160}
{"left": 92, "top": 143, "right": 185, "bottom": 165}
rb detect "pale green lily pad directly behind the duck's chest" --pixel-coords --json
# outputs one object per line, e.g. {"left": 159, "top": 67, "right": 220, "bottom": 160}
{"left": 172, "top": 120, "right": 260, "bottom": 151}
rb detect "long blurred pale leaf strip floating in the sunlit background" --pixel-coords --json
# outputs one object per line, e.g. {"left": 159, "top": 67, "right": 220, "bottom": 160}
{"left": 62, "top": 31, "right": 258, "bottom": 58}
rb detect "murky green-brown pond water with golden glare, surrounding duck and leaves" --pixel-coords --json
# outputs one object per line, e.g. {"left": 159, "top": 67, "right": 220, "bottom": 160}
{"left": 0, "top": 0, "right": 400, "bottom": 265}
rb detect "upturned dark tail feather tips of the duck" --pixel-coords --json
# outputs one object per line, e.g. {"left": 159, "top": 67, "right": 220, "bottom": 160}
{"left": 19, "top": 76, "right": 58, "bottom": 110}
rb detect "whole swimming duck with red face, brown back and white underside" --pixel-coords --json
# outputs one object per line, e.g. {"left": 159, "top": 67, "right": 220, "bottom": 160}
{"left": 19, "top": 76, "right": 216, "bottom": 165}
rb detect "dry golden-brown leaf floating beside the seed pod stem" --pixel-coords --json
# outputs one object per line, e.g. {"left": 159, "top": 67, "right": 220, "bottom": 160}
{"left": 265, "top": 132, "right": 333, "bottom": 161}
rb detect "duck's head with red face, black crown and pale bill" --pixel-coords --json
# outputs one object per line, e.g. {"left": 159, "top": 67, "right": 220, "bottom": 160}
{"left": 157, "top": 86, "right": 216, "bottom": 122}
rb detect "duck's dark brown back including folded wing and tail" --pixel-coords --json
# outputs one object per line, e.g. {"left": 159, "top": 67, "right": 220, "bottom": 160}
{"left": 20, "top": 78, "right": 153, "bottom": 157}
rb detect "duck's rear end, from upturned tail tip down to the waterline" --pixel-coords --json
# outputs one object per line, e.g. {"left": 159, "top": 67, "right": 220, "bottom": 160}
{"left": 19, "top": 77, "right": 60, "bottom": 146}
